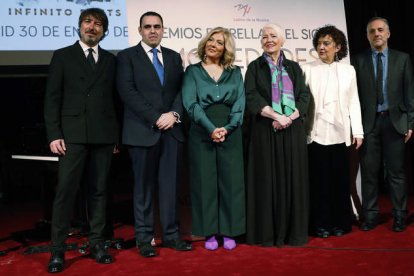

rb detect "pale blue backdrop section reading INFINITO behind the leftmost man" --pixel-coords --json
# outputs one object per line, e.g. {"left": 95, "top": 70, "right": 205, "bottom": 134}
{"left": 0, "top": 0, "right": 128, "bottom": 51}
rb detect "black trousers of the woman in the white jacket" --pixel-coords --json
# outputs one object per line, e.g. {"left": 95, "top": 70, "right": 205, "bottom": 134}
{"left": 308, "top": 142, "right": 352, "bottom": 232}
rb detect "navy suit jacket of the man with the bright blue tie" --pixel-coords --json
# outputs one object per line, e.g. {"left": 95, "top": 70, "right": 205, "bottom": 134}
{"left": 117, "top": 43, "right": 184, "bottom": 146}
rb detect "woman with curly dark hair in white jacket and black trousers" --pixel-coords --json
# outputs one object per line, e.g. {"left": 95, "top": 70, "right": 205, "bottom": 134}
{"left": 302, "top": 25, "right": 363, "bottom": 238}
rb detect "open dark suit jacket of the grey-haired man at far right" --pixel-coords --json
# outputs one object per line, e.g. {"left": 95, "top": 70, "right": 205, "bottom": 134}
{"left": 352, "top": 49, "right": 414, "bottom": 134}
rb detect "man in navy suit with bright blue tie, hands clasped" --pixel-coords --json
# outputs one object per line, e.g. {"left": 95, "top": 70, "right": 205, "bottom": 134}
{"left": 117, "top": 12, "right": 191, "bottom": 257}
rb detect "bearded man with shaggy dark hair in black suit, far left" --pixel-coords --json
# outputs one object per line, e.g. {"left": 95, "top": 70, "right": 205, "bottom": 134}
{"left": 44, "top": 8, "right": 119, "bottom": 273}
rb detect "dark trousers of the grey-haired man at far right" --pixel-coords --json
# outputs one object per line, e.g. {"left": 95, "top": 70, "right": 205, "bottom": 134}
{"left": 361, "top": 115, "right": 407, "bottom": 220}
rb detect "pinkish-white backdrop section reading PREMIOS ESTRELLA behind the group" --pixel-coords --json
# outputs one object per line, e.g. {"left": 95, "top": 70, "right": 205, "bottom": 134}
{"left": 126, "top": 0, "right": 349, "bottom": 72}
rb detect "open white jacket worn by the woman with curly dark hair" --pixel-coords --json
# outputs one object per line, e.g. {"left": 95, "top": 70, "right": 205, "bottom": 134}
{"left": 301, "top": 59, "right": 364, "bottom": 146}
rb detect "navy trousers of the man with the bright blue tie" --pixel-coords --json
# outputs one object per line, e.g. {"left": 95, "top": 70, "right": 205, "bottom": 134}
{"left": 128, "top": 133, "right": 183, "bottom": 243}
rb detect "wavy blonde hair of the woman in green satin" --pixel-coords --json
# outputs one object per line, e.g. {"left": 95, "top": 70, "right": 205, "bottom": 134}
{"left": 197, "top": 27, "right": 236, "bottom": 69}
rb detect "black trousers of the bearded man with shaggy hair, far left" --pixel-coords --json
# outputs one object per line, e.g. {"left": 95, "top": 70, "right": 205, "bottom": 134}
{"left": 52, "top": 144, "right": 114, "bottom": 247}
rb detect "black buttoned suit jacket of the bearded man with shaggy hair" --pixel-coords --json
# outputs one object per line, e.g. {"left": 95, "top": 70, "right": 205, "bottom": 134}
{"left": 44, "top": 42, "right": 119, "bottom": 144}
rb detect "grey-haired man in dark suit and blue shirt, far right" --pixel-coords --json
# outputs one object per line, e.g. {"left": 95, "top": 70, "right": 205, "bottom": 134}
{"left": 352, "top": 17, "right": 414, "bottom": 232}
